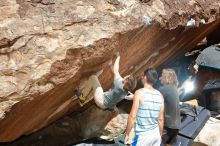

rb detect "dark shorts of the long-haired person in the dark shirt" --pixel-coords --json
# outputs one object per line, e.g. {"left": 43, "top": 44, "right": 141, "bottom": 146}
{"left": 162, "top": 127, "right": 179, "bottom": 145}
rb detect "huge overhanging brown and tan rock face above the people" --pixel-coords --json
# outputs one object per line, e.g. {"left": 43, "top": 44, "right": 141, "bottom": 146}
{"left": 0, "top": 0, "right": 220, "bottom": 142}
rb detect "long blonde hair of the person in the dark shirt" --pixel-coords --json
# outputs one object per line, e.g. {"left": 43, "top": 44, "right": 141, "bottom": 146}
{"left": 162, "top": 68, "right": 179, "bottom": 87}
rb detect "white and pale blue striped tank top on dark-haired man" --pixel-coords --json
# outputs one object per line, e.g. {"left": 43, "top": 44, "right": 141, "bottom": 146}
{"left": 135, "top": 88, "right": 163, "bottom": 135}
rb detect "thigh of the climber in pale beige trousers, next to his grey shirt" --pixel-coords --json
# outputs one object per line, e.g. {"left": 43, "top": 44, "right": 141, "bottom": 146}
{"left": 90, "top": 75, "right": 106, "bottom": 109}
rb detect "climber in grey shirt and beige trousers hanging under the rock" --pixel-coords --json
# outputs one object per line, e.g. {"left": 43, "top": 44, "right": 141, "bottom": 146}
{"left": 90, "top": 53, "right": 136, "bottom": 109}
